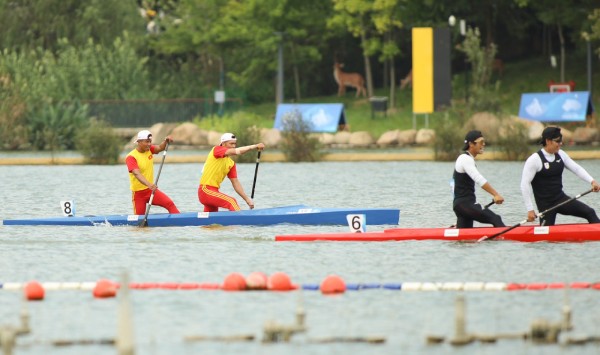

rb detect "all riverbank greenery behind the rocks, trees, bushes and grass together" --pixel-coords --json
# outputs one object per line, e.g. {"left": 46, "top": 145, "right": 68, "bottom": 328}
{"left": 0, "top": 0, "right": 600, "bottom": 163}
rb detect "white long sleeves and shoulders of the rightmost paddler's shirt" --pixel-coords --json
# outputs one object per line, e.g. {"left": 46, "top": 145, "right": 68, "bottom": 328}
{"left": 521, "top": 148, "right": 594, "bottom": 211}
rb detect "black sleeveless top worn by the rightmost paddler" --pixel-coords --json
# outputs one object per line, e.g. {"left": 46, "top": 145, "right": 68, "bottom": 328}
{"left": 531, "top": 150, "right": 565, "bottom": 210}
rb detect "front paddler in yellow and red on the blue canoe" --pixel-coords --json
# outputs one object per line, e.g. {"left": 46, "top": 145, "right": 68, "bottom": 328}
{"left": 198, "top": 133, "right": 265, "bottom": 212}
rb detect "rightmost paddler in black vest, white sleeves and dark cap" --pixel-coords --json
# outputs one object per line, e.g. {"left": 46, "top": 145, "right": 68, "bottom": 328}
{"left": 521, "top": 127, "right": 600, "bottom": 226}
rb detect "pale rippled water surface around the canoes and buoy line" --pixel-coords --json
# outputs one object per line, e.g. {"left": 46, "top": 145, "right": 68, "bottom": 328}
{"left": 0, "top": 158, "right": 600, "bottom": 354}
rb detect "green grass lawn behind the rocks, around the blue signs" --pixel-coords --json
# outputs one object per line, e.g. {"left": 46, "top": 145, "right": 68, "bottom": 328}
{"left": 237, "top": 54, "right": 600, "bottom": 138}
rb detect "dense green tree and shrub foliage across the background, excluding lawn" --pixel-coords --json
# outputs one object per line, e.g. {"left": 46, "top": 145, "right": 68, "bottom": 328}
{"left": 0, "top": 0, "right": 600, "bottom": 153}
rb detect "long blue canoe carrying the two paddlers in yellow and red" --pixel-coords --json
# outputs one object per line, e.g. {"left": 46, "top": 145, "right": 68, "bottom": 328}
{"left": 0, "top": 205, "right": 400, "bottom": 227}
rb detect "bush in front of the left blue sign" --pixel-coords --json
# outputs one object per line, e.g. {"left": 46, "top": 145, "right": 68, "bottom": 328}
{"left": 281, "top": 112, "right": 322, "bottom": 162}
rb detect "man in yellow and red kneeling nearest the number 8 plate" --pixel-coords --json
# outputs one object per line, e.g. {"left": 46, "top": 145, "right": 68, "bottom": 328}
{"left": 125, "top": 130, "right": 179, "bottom": 215}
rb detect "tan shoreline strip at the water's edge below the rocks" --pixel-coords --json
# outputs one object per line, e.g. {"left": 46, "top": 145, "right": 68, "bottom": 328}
{"left": 0, "top": 148, "right": 600, "bottom": 166}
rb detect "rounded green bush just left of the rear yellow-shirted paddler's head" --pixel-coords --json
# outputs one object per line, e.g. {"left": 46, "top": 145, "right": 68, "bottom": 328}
{"left": 76, "top": 119, "right": 122, "bottom": 165}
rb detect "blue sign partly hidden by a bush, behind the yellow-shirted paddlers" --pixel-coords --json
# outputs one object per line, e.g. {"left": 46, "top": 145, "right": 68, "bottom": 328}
{"left": 273, "top": 104, "right": 346, "bottom": 133}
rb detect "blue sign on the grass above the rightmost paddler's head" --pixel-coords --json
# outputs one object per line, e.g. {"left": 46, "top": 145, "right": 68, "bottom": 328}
{"left": 519, "top": 91, "right": 594, "bottom": 122}
